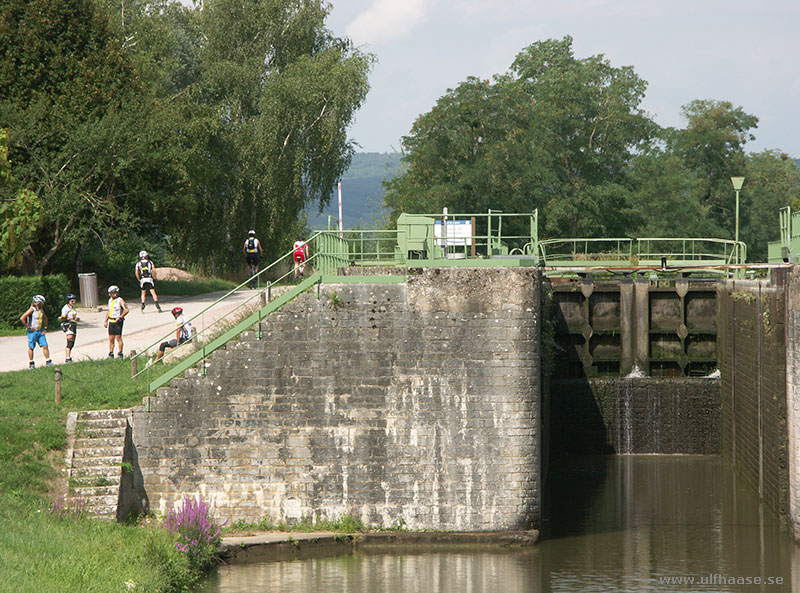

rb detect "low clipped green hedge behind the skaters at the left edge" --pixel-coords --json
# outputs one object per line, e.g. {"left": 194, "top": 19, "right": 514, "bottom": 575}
{"left": 0, "top": 274, "right": 69, "bottom": 329}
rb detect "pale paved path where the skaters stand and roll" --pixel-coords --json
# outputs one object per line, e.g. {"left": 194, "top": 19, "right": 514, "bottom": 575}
{"left": 0, "top": 290, "right": 258, "bottom": 372}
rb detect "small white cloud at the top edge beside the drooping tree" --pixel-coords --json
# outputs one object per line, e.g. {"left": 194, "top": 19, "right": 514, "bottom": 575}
{"left": 347, "top": 0, "right": 430, "bottom": 45}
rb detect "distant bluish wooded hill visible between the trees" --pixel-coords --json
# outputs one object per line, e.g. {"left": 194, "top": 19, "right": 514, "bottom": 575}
{"left": 308, "top": 152, "right": 401, "bottom": 228}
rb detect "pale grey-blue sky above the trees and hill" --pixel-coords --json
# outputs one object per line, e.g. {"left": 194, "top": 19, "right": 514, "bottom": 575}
{"left": 327, "top": 0, "right": 800, "bottom": 158}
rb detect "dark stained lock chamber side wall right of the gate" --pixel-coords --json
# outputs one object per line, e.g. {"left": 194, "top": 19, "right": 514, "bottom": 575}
{"left": 718, "top": 273, "right": 800, "bottom": 516}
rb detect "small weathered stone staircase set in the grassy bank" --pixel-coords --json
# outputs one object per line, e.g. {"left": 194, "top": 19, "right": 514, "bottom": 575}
{"left": 67, "top": 410, "right": 128, "bottom": 520}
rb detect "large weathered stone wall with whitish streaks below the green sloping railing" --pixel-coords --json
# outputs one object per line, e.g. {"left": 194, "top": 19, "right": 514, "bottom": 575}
{"left": 133, "top": 268, "right": 541, "bottom": 531}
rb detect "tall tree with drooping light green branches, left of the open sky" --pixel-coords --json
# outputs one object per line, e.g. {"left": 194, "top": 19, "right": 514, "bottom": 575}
{"left": 173, "top": 0, "right": 372, "bottom": 267}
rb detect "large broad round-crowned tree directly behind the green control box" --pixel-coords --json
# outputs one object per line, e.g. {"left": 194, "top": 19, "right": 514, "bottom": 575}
{"left": 386, "top": 37, "right": 657, "bottom": 236}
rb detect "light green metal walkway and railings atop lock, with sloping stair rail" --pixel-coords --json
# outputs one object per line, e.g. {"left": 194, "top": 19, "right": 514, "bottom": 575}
{"left": 133, "top": 210, "right": 752, "bottom": 392}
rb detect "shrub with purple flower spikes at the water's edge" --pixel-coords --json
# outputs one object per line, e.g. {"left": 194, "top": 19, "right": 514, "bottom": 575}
{"left": 164, "top": 496, "right": 222, "bottom": 568}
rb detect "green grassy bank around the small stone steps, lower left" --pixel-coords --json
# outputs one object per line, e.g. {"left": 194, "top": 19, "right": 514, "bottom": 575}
{"left": 0, "top": 360, "right": 203, "bottom": 593}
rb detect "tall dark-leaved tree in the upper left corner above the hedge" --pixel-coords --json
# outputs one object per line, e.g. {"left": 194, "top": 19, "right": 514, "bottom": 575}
{"left": 0, "top": 0, "right": 186, "bottom": 274}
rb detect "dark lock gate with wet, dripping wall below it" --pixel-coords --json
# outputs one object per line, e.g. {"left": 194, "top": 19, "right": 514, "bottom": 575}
{"left": 545, "top": 278, "right": 720, "bottom": 455}
